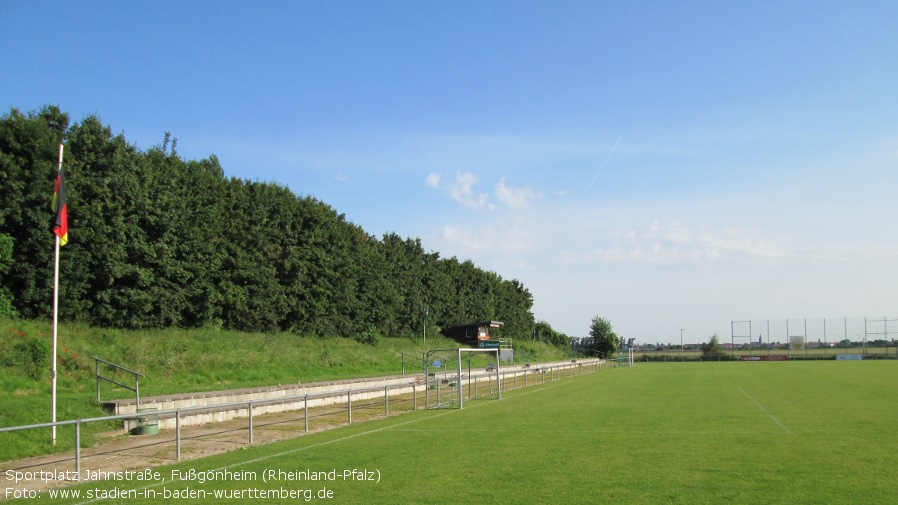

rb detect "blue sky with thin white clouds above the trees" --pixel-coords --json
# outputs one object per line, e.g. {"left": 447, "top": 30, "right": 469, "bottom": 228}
{"left": 0, "top": 0, "right": 898, "bottom": 342}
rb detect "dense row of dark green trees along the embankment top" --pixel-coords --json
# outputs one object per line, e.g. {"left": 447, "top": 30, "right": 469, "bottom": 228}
{"left": 0, "top": 106, "right": 567, "bottom": 345}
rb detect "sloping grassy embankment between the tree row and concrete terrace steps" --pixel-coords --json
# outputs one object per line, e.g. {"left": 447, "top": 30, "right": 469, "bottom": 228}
{"left": 0, "top": 320, "right": 563, "bottom": 461}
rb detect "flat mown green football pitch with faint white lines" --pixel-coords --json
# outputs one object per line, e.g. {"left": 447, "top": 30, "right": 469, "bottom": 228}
{"left": 14, "top": 361, "right": 898, "bottom": 504}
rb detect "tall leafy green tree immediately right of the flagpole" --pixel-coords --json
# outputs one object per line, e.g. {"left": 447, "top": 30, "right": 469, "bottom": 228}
{"left": 61, "top": 116, "right": 146, "bottom": 327}
